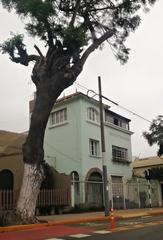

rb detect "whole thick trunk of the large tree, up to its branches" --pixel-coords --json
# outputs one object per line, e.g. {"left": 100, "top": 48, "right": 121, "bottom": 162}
{"left": 16, "top": 48, "right": 81, "bottom": 223}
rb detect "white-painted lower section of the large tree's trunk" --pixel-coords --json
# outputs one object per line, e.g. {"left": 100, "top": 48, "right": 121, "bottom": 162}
{"left": 16, "top": 163, "right": 44, "bottom": 224}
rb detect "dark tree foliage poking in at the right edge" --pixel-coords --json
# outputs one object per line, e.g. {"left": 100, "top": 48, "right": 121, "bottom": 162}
{"left": 143, "top": 115, "right": 163, "bottom": 157}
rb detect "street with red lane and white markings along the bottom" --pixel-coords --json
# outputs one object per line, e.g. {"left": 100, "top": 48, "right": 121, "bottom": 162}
{"left": 0, "top": 216, "right": 163, "bottom": 240}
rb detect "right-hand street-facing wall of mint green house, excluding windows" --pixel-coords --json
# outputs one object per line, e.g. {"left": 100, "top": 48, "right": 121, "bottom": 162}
{"left": 78, "top": 97, "right": 132, "bottom": 178}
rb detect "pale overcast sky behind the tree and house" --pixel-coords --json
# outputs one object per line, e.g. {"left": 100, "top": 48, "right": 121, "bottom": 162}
{"left": 0, "top": 0, "right": 163, "bottom": 157}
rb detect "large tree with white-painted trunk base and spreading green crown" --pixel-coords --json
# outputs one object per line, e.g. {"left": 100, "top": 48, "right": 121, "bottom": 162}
{"left": 0, "top": 0, "right": 156, "bottom": 223}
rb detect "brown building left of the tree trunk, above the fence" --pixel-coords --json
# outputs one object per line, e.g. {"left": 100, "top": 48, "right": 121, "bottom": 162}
{"left": 0, "top": 130, "right": 26, "bottom": 190}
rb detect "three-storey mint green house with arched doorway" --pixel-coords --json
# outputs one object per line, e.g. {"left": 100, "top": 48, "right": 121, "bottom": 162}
{"left": 30, "top": 92, "right": 133, "bottom": 207}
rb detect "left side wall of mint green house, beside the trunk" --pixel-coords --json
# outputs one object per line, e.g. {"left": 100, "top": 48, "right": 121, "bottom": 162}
{"left": 44, "top": 97, "right": 81, "bottom": 174}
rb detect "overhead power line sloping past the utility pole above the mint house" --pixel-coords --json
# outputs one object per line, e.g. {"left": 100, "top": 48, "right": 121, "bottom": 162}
{"left": 75, "top": 83, "right": 152, "bottom": 123}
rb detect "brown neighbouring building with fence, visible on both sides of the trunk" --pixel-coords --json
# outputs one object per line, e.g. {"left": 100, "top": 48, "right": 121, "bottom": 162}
{"left": 0, "top": 130, "right": 71, "bottom": 210}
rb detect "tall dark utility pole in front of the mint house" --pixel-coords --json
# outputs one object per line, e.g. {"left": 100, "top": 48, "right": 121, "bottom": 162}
{"left": 98, "top": 76, "right": 109, "bottom": 216}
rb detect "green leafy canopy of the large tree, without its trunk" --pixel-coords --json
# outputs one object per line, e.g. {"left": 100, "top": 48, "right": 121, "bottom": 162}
{"left": 0, "top": 0, "right": 156, "bottom": 63}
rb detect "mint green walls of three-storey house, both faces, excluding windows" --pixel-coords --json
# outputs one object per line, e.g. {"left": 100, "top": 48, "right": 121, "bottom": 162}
{"left": 44, "top": 96, "right": 132, "bottom": 180}
